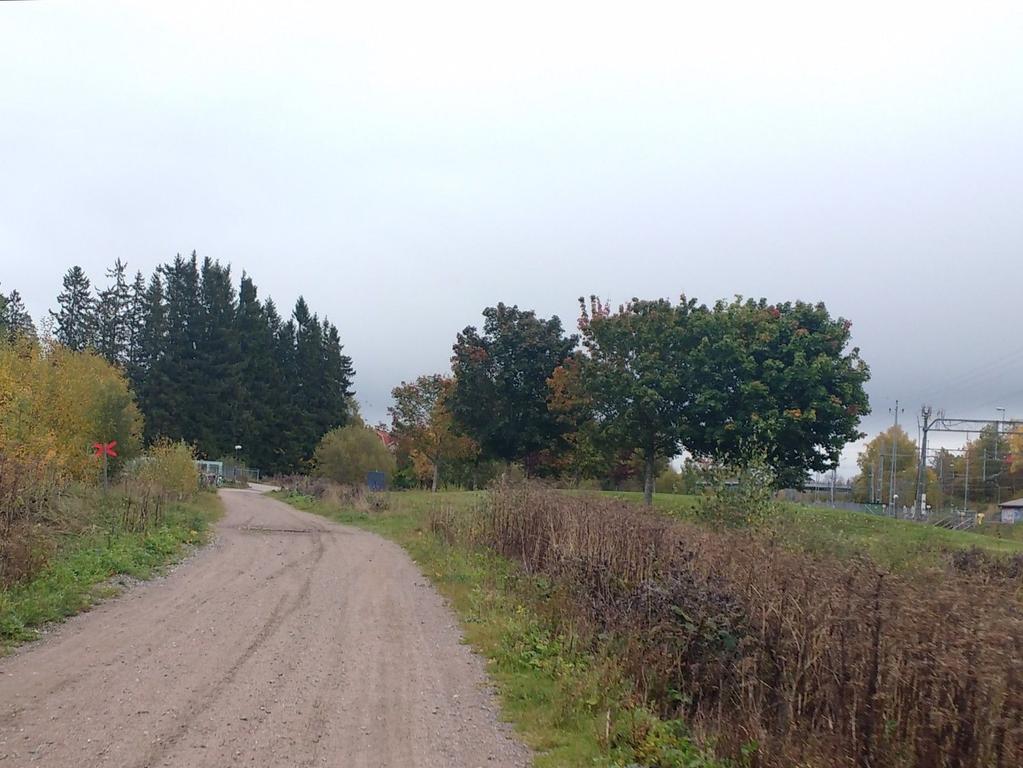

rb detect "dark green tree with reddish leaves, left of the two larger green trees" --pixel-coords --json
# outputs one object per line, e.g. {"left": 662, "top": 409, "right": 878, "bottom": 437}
{"left": 448, "top": 304, "right": 578, "bottom": 473}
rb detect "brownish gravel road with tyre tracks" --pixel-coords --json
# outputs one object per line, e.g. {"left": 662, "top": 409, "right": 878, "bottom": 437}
{"left": 0, "top": 491, "right": 529, "bottom": 768}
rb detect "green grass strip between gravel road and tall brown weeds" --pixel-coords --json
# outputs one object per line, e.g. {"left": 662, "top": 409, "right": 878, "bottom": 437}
{"left": 274, "top": 492, "right": 725, "bottom": 768}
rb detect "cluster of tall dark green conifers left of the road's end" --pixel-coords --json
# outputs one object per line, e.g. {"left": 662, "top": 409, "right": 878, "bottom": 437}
{"left": 43, "top": 252, "right": 355, "bottom": 472}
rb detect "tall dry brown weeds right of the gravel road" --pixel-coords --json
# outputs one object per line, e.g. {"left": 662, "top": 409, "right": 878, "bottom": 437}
{"left": 432, "top": 485, "right": 1023, "bottom": 768}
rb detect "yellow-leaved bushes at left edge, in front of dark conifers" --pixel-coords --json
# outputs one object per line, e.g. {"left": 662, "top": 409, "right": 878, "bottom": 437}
{"left": 0, "top": 341, "right": 142, "bottom": 481}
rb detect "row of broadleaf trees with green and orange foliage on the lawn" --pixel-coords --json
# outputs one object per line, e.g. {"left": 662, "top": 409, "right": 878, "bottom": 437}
{"left": 390, "top": 295, "right": 870, "bottom": 504}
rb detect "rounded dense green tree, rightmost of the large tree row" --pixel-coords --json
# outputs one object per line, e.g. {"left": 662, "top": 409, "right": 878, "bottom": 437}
{"left": 685, "top": 299, "right": 870, "bottom": 488}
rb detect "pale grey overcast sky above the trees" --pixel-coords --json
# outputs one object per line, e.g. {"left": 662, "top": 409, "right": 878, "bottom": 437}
{"left": 0, "top": 0, "right": 1023, "bottom": 471}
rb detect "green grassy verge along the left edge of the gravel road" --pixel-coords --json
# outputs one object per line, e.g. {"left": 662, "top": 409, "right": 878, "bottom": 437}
{"left": 0, "top": 492, "right": 221, "bottom": 656}
